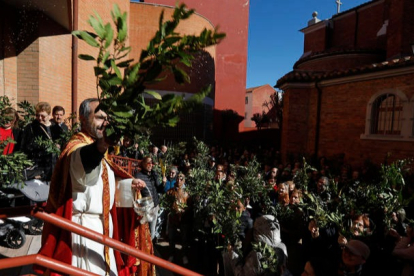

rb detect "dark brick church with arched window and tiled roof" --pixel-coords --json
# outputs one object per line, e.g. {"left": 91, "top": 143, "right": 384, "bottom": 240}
{"left": 276, "top": 0, "right": 414, "bottom": 166}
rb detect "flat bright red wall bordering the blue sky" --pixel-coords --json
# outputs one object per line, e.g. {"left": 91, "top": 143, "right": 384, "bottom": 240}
{"left": 145, "top": 0, "right": 249, "bottom": 134}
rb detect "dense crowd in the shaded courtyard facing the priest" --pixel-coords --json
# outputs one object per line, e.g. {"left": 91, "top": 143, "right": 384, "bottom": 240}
{"left": 114, "top": 133, "right": 414, "bottom": 275}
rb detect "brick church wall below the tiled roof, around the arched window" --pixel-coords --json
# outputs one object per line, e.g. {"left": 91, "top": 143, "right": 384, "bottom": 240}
{"left": 282, "top": 74, "right": 414, "bottom": 166}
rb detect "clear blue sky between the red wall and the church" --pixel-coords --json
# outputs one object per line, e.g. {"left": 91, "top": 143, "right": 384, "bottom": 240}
{"left": 246, "top": 0, "right": 370, "bottom": 88}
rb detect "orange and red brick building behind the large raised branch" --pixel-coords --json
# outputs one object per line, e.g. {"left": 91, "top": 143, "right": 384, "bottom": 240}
{"left": 0, "top": 0, "right": 249, "bottom": 143}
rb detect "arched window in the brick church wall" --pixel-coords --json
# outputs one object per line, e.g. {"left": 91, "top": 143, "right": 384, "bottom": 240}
{"left": 370, "top": 94, "right": 403, "bottom": 135}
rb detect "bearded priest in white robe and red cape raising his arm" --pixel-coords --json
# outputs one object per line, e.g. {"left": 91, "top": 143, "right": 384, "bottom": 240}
{"left": 35, "top": 99, "right": 150, "bottom": 275}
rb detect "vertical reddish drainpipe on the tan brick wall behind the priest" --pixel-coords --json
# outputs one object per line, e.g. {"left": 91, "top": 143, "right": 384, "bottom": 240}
{"left": 69, "top": 0, "right": 78, "bottom": 123}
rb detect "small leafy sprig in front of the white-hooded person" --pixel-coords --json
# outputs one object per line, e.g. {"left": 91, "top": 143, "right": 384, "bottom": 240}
{"left": 252, "top": 242, "right": 280, "bottom": 275}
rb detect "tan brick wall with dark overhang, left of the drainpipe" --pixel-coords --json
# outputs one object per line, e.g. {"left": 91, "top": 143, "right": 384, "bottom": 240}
{"left": 1, "top": 6, "right": 71, "bottom": 110}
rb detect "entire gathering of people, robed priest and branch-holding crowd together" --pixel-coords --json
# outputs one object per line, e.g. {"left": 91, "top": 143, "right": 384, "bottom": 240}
{"left": 0, "top": 99, "right": 414, "bottom": 276}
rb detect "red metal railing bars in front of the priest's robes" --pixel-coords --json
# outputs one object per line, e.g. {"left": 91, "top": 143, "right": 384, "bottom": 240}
{"left": 0, "top": 206, "right": 200, "bottom": 276}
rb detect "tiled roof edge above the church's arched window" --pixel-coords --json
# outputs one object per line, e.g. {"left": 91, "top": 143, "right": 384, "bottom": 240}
{"left": 275, "top": 56, "right": 414, "bottom": 88}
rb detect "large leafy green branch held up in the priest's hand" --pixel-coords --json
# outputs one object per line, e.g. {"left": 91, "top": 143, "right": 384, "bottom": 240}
{"left": 73, "top": 4, "right": 225, "bottom": 140}
